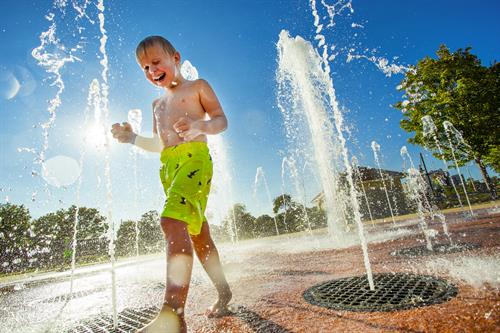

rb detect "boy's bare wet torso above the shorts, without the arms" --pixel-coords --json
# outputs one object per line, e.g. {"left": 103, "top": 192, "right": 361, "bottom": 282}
{"left": 153, "top": 81, "right": 207, "bottom": 147}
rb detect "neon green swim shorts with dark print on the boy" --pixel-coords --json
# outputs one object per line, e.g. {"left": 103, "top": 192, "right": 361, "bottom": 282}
{"left": 160, "top": 142, "right": 213, "bottom": 235}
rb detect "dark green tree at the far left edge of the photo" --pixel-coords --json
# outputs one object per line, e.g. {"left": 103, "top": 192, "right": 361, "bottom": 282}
{"left": 0, "top": 203, "right": 31, "bottom": 272}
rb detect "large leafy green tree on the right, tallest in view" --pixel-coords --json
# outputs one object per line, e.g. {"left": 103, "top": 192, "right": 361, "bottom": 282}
{"left": 394, "top": 45, "right": 500, "bottom": 197}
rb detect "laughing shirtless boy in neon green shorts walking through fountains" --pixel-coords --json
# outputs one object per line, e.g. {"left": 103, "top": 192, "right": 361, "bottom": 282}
{"left": 111, "top": 36, "right": 232, "bottom": 332}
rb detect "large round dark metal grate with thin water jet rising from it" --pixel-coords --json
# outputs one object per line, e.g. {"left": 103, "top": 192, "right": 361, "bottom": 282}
{"left": 304, "top": 273, "right": 457, "bottom": 312}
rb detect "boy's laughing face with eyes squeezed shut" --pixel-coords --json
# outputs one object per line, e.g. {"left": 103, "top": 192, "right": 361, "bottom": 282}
{"left": 139, "top": 44, "right": 180, "bottom": 88}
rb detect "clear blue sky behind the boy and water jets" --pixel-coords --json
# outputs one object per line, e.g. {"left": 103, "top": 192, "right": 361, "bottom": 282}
{"left": 0, "top": 0, "right": 500, "bottom": 223}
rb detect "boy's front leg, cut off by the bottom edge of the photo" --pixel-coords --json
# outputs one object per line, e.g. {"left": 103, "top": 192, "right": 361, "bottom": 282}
{"left": 143, "top": 217, "right": 193, "bottom": 333}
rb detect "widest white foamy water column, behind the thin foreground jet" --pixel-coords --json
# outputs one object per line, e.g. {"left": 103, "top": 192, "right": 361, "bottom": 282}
{"left": 277, "top": 31, "right": 345, "bottom": 235}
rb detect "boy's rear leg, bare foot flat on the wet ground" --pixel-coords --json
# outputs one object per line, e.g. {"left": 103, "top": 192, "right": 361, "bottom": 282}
{"left": 190, "top": 222, "right": 232, "bottom": 316}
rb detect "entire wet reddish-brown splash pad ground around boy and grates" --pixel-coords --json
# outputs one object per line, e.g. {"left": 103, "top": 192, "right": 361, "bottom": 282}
{"left": 0, "top": 204, "right": 500, "bottom": 333}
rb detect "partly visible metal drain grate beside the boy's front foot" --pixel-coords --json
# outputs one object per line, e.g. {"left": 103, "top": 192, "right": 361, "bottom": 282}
{"left": 67, "top": 307, "right": 160, "bottom": 333}
